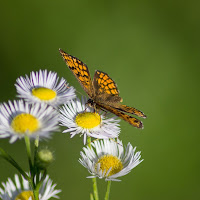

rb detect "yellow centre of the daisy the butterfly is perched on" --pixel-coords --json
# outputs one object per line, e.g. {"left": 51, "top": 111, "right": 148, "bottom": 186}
{"left": 75, "top": 112, "right": 101, "bottom": 129}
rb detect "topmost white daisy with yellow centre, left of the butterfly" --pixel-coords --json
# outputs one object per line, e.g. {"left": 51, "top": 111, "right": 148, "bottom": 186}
{"left": 15, "top": 70, "right": 76, "bottom": 107}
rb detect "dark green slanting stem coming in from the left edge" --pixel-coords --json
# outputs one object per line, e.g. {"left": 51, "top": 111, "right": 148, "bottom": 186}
{"left": 0, "top": 148, "right": 30, "bottom": 181}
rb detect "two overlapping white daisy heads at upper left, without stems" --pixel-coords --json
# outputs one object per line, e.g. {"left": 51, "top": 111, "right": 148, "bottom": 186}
{"left": 0, "top": 70, "right": 76, "bottom": 143}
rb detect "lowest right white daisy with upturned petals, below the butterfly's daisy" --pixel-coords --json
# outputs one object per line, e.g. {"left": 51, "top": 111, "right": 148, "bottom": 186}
{"left": 79, "top": 140, "right": 143, "bottom": 181}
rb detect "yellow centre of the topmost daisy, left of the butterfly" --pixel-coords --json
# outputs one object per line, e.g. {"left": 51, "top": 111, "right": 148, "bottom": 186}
{"left": 32, "top": 87, "right": 56, "bottom": 101}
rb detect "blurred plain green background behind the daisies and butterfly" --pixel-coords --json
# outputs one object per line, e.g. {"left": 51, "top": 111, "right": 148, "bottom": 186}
{"left": 0, "top": 0, "right": 200, "bottom": 200}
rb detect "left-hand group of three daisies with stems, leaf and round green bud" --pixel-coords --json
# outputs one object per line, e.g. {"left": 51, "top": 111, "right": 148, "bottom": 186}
{"left": 0, "top": 70, "right": 76, "bottom": 200}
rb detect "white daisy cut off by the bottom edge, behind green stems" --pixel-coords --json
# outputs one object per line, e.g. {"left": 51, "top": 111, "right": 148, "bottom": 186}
{"left": 0, "top": 174, "right": 61, "bottom": 200}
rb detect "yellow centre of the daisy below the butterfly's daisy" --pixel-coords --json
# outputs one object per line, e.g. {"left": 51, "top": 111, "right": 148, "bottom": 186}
{"left": 96, "top": 155, "right": 123, "bottom": 176}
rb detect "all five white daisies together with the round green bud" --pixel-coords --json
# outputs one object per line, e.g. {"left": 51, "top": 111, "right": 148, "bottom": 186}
{"left": 0, "top": 70, "right": 143, "bottom": 200}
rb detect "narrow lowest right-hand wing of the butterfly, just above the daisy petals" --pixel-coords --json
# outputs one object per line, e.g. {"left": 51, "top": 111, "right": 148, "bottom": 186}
{"left": 98, "top": 104, "right": 143, "bottom": 128}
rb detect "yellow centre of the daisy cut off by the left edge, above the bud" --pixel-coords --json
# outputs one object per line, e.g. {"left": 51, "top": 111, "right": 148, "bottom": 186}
{"left": 11, "top": 113, "right": 39, "bottom": 134}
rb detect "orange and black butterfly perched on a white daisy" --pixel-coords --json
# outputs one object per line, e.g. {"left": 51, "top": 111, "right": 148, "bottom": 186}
{"left": 59, "top": 49, "right": 146, "bottom": 128}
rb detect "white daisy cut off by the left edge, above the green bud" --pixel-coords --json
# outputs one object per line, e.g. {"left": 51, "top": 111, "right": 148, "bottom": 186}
{"left": 0, "top": 100, "right": 59, "bottom": 143}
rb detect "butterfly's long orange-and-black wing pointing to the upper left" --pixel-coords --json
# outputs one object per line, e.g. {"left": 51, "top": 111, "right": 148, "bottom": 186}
{"left": 59, "top": 49, "right": 94, "bottom": 97}
